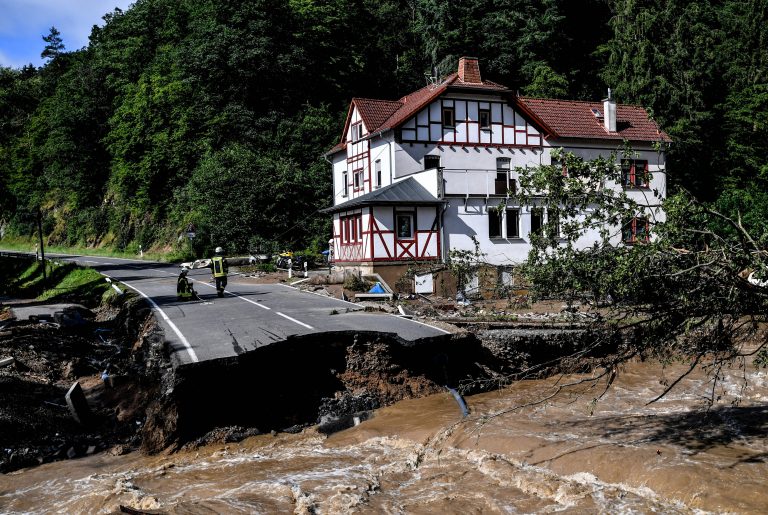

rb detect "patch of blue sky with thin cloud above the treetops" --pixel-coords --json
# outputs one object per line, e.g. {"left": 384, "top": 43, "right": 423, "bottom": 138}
{"left": 0, "top": 0, "right": 136, "bottom": 68}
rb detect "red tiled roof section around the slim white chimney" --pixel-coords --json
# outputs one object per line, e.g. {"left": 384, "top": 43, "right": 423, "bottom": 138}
{"left": 517, "top": 97, "right": 672, "bottom": 141}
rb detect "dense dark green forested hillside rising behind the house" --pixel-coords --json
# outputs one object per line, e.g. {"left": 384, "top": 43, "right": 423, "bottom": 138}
{"left": 0, "top": 0, "right": 768, "bottom": 254}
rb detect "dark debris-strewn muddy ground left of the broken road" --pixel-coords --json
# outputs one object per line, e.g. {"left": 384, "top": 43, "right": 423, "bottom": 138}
{"left": 0, "top": 299, "right": 164, "bottom": 472}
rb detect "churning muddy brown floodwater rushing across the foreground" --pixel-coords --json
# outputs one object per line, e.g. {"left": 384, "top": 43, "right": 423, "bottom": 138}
{"left": 0, "top": 354, "right": 768, "bottom": 514}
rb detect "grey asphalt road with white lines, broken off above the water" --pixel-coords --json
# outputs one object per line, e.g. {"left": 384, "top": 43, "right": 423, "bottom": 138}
{"left": 30, "top": 255, "right": 447, "bottom": 366}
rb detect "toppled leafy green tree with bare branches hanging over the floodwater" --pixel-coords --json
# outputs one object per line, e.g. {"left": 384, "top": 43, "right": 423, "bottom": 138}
{"left": 472, "top": 147, "right": 768, "bottom": 410}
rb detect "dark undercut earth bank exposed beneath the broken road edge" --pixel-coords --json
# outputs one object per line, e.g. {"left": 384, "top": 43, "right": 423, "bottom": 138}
{"left": 143, "top": 331, "right": 493, "bottom": 452}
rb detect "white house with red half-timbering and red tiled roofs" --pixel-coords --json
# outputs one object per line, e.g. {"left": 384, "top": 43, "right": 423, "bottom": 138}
{"left": 325, "top": 57, "right": 670, "bottom": 288}
